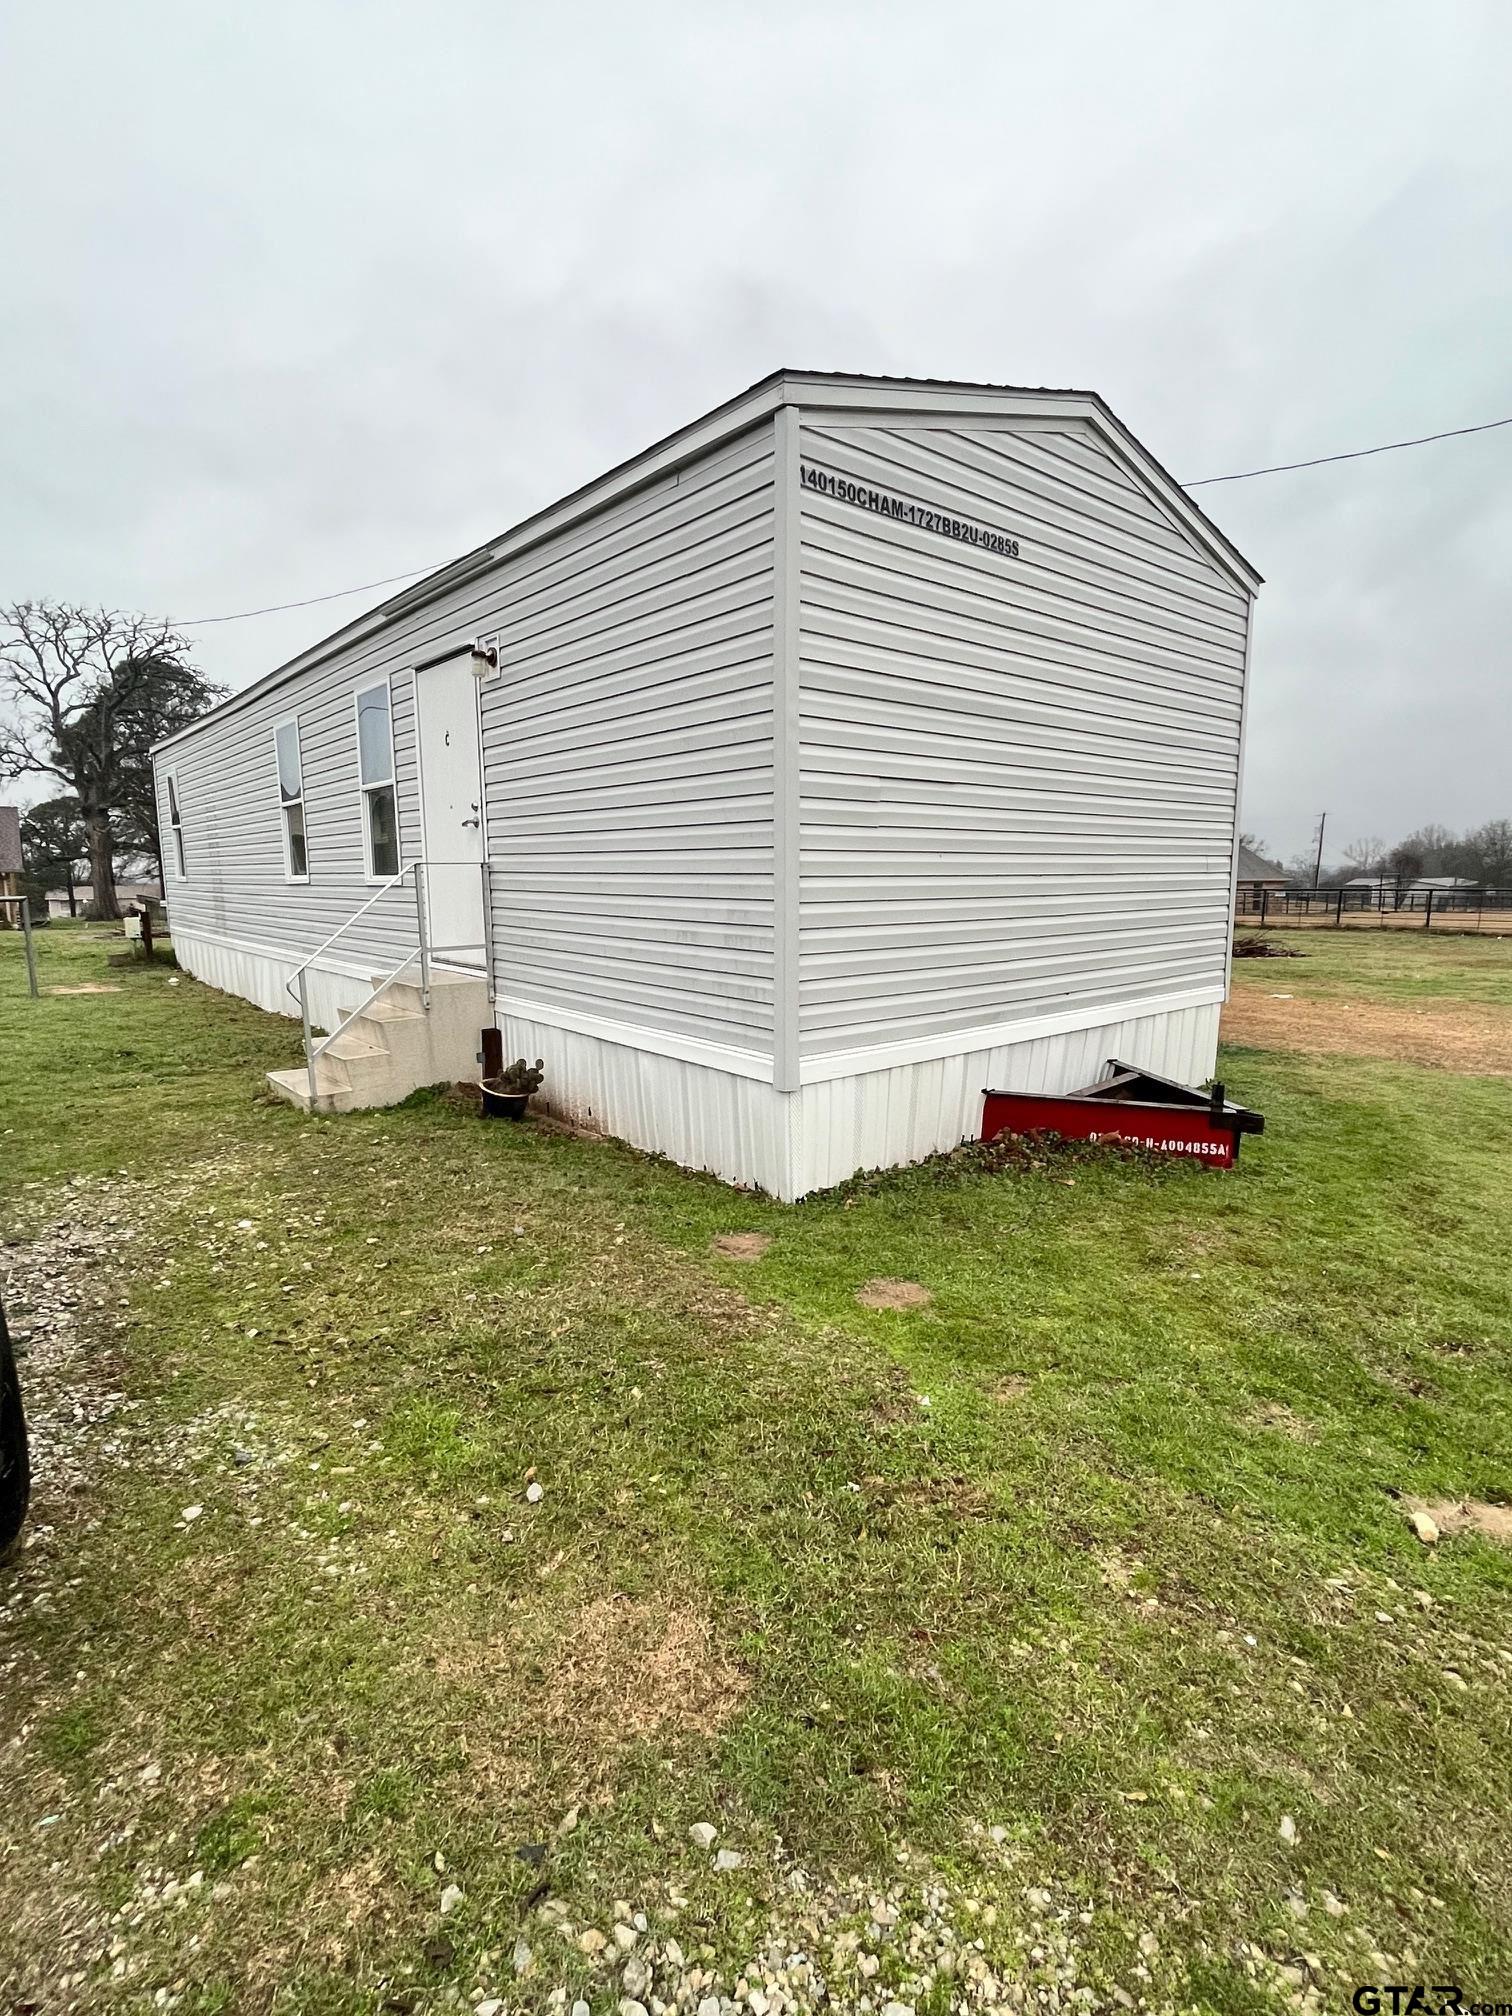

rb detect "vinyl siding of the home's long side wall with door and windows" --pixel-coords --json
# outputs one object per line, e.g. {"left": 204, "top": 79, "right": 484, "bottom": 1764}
{"left": 157, "top": 421, "right": 772, "bottom": 1056}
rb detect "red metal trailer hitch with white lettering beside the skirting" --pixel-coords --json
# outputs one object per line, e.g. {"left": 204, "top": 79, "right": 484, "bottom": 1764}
{"left": 982, "top": 1056, "right": 1266, "bottom": 1169}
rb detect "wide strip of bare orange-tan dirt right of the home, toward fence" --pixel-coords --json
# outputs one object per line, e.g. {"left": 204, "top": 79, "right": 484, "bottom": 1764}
{"left": 1224, "top": 988, "right": 1512, "bottom": 1077}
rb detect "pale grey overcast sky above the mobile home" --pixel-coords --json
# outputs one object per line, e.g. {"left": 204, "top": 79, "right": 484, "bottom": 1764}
{"left": 0, "top": 0, "right": 1512, "bottom": 853}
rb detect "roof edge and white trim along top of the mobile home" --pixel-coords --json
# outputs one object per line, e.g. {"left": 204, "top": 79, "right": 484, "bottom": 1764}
{"left": 153, "top": 367, "right": 1264, "bottom": 754}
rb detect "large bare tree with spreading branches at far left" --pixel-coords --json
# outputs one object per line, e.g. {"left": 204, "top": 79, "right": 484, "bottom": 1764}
{"left": 0, "top": 603, "right": 216, "bottom": 917}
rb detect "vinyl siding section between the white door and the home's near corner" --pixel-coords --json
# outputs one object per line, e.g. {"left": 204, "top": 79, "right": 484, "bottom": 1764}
{"left": 482, "top": 423, "right": 772, "bottom": 1056}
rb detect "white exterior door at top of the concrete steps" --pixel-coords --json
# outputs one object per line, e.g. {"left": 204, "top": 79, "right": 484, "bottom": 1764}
{"left": 415, "top": 653, "right": 484, "bottom": 966}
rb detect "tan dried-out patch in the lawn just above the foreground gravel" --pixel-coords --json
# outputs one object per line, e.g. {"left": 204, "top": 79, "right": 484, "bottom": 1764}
{"left": 540, "top": 1597, "right": 750, "bottom": 1752}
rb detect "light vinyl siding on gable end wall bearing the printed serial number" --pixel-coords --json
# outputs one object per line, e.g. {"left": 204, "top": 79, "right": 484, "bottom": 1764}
{"left": 798, "top": 421, "right": 1248, "bottom": 1054}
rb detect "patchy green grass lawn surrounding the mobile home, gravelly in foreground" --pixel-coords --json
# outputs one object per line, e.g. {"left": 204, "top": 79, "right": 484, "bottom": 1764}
{"left": 0, "top": 927, "right": 1512, "bottom": 2016}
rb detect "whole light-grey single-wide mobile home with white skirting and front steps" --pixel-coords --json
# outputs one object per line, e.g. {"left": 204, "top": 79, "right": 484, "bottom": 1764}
{"left": 155, "top": 373, "right": 1260, "bottom": 1198}
